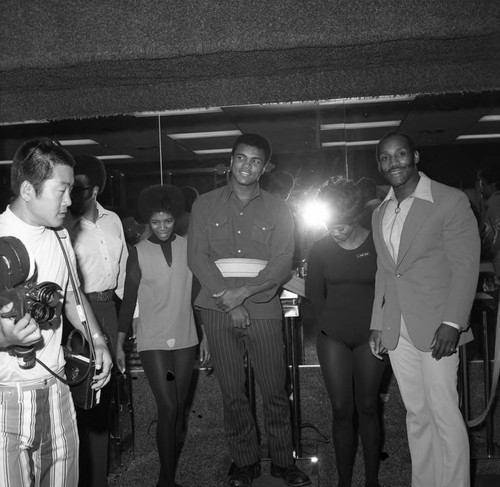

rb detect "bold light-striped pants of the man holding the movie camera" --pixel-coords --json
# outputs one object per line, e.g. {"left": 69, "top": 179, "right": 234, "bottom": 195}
{"left": 0, "top": 380, "right": 78, "bottom": 487}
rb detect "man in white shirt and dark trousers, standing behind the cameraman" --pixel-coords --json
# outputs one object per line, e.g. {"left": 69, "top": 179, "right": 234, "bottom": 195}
{"left": 65, "top": 155, "right": 128, "bottom": 487}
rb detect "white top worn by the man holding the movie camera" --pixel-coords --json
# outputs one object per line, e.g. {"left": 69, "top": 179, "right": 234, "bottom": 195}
{"left": 0, "top": 207, "right": 78, "bottom": 385}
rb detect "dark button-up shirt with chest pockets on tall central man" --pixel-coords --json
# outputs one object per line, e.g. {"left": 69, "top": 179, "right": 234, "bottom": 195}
{"left": 188, "top": 182, "right": 294, "bottom": 319}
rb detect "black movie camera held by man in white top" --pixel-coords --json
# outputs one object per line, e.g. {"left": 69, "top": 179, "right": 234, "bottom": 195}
{"left": 0, "top": 237, "right": 62, "bottom": 369}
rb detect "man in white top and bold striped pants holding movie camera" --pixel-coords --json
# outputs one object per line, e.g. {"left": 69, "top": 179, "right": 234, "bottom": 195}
{"left": 0, "top": 138, "right": 112, "bottom": 487}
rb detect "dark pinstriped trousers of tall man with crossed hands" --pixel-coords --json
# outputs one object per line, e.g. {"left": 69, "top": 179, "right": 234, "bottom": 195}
{"left": 201, "top": 309, "right": 293, "bottom": 467}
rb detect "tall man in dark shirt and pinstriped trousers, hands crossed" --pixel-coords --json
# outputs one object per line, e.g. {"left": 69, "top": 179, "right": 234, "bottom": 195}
{"left": 188, "top": 134, "right": 311, "bottom": 487}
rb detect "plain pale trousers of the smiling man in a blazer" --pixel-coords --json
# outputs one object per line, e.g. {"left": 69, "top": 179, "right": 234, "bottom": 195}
{"left": 389, "top": 320, "right": 470, "bottom": 487}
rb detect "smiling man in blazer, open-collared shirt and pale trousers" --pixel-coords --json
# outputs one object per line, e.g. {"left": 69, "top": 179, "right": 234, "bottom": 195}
{"left": 370, "top": 132, "right": 480, "bottom": 487}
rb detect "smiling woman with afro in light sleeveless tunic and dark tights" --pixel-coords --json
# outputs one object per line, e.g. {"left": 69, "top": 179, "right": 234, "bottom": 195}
{"left": 116, "top": 185, "right": 208, "bottom": 487}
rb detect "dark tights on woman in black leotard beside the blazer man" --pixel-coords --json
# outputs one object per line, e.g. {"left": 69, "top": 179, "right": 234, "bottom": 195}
{"left": 317, "top": 333, "right": 385, "bottom": 487}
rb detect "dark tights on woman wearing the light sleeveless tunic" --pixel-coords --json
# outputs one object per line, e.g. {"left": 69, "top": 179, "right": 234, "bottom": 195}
{"left": 139, "top": 347, "right": 196, "bottom": 487}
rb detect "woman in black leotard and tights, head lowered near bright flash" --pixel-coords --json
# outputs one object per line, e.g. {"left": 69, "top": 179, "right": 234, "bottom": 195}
{"left": 306, "top": 177, "right": 385, "bottom": 487}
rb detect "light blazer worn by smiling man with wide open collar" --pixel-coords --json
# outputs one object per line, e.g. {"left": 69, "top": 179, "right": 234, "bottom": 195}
{"left": 371, "top": 181, "right": 480, "bottom": 351}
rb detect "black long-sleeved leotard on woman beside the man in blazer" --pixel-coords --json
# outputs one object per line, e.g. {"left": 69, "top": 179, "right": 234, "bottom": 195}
{"left": 306, "top": 232, "right": 377, "bottom": 346}
